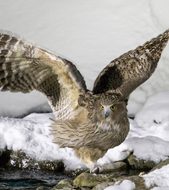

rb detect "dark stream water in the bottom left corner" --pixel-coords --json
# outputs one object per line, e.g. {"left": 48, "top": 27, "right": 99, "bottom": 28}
{"left": 0, "top": 170, "right": 68, "bottom": 190}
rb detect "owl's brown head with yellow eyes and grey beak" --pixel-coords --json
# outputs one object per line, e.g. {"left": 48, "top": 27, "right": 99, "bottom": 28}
{"left": 79, "top": 91, "right": 127, "bottom": 121}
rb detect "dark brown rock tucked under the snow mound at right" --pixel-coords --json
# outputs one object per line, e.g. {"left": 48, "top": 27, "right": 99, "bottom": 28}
{"left": 127, "top": 154, "right": 156, "bottom": 171}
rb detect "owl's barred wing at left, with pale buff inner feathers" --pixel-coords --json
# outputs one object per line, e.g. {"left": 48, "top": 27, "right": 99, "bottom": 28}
{"left": 0, "top": 33, "right": 86, "bottom": 119}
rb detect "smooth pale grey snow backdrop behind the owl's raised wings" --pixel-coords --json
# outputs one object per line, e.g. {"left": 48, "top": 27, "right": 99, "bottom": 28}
{"left": 0, "top": 0, "right": 169, "bottom": 117}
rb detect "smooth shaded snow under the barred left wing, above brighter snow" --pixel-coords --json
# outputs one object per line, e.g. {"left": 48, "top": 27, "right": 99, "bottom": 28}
{"left": 0, "top": 91, "right": 51, "bottom": 117}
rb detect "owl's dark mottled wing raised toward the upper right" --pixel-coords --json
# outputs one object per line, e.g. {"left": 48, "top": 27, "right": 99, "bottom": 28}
{"left": 93, "top": 30, "right": 169, "bottom": 98}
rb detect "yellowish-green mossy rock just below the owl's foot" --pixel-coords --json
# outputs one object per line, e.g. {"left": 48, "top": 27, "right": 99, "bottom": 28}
{"left": 73, "top": 173, "right": 113, "bottom": 187}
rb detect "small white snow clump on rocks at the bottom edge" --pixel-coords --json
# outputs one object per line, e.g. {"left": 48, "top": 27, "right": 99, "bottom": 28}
{"left": 104, "top": 180, "right": 135, "bottom": 190}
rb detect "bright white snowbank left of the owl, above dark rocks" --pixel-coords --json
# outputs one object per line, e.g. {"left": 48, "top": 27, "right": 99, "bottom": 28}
{"left": 0, "top": 114, "right": 84, "bottom": 170}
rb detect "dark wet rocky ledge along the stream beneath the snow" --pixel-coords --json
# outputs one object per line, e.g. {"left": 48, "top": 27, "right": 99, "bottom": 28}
{"left": 0, "top": 150, "right": 169, "bottom": 190}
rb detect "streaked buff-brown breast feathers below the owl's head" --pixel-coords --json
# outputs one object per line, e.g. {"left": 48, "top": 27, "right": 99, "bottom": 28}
{"left": 52, "top": 107, "right": 129, "bottom": 150}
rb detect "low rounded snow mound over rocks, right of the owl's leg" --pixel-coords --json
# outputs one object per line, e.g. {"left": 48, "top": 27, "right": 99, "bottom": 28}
{"left": 97, "top": 136, "right": 169, "bottom": 165}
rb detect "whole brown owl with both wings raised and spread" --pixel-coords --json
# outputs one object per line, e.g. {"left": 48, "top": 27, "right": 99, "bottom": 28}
{"left": 0, "top": 30, "right": 169, "bottom": 171}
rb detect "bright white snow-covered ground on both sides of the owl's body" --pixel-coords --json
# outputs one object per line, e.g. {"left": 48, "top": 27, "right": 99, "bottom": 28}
{"left": 0, "top": 92, "right": 169, "bottom": 189}
